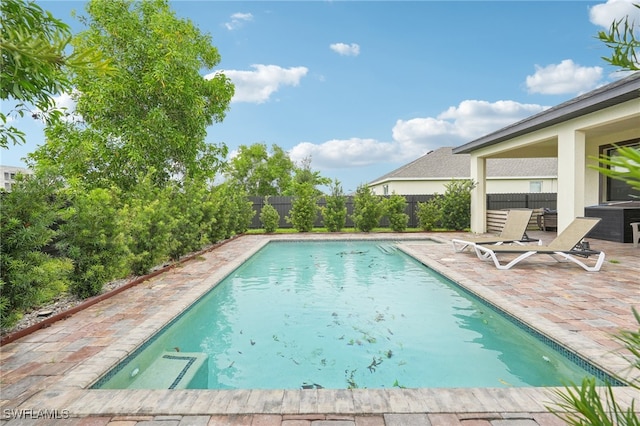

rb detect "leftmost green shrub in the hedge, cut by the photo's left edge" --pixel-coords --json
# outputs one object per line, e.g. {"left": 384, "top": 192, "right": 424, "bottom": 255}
{"left": 0, "top": 171, "right": 73, "bottom": 326}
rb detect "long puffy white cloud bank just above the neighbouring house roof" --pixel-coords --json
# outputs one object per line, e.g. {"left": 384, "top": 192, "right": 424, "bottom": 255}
{"left": 289, "top": 100, "right": 546, "bottom": 170}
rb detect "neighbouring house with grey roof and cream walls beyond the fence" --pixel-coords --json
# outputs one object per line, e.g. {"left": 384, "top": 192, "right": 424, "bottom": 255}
{"left": 369, "top": 147, "right": 558, "bottom": 195}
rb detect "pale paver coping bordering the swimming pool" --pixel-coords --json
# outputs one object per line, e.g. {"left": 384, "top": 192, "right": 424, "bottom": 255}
{"left": 3, "top": 234, "right": 637, "bottom": 417}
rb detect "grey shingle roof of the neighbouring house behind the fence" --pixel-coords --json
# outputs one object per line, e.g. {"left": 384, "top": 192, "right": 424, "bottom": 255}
{"left": 370, "top": 147, "right": 558, "bottom": 185}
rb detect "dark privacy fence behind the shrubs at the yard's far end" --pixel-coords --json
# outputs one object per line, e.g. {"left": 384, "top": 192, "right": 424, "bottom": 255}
{"left": 249, "top": 193, "right": 557, "bottom": 229}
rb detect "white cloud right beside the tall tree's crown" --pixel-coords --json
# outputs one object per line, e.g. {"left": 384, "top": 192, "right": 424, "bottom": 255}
{"left": 204, "top": 64, "right": 309, "bottom": 104}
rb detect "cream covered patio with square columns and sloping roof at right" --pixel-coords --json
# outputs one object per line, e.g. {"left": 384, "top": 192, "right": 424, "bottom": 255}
{"left": 453, "top": 72, "right": 640, "bottom": 232}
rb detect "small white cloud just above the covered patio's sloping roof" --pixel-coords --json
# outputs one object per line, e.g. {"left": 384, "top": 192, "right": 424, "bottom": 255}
{"left": 526, "top": 59, "right": 603, "bottom": 95}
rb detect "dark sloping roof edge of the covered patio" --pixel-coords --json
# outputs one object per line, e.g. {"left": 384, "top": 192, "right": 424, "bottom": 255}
{"left": 453, "top": 72, "right": 640, "bottom": 154}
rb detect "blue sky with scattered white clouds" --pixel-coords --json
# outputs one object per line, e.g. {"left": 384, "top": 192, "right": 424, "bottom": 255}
{"left": 0, "top": 0, "right": 640, "bottom": 192}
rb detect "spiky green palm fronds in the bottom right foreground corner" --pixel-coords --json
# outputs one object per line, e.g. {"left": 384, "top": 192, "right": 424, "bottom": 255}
{"left": 547, "top": 308, "right": 640, "bottom": 426}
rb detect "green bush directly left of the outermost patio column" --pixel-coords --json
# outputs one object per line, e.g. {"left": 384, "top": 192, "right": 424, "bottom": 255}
{"left": 440, "top": 180, "right": 475, "bottom": 231}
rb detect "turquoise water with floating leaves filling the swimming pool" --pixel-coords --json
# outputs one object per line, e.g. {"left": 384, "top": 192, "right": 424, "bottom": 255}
{"left": 95, "top": 241, "right": 608, "bottom": 389}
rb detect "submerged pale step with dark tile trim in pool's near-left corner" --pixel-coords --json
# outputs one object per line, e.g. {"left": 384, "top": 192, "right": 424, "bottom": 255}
{"left": 128, "top": 351, "right": 209, "bottom": 389}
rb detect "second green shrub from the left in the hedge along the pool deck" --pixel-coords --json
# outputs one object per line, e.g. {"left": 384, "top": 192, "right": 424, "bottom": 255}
{"left": 56, "top": 186, "right": 130, "bottom": 297}
